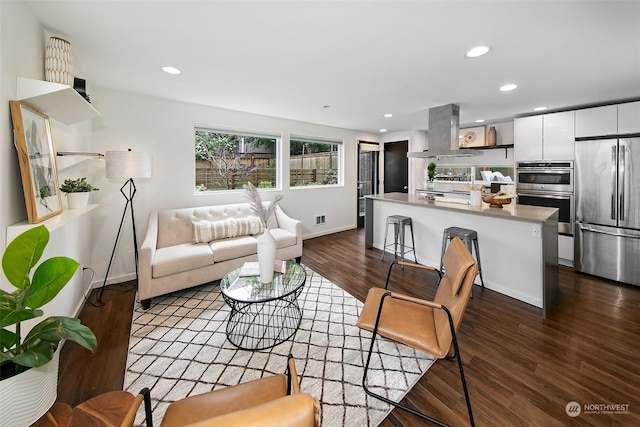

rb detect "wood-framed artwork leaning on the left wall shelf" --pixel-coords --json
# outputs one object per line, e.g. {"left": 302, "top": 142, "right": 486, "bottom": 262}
{"left": 9, "top": 101, "right": 62, "bottom": 224}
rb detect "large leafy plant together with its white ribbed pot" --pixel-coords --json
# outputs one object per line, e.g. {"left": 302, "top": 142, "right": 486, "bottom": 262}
{"left": 0, "top": 225, "right": 97, "bottom": 425}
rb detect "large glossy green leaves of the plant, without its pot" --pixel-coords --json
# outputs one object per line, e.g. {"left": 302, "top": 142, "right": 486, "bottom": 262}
{"left": 0, "top": 225, "right": 96, "bottom": 379}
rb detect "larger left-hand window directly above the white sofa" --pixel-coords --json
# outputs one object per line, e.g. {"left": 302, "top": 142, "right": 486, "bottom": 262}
{"left": 195, "top": 128, "right": 278, "bottom": 191}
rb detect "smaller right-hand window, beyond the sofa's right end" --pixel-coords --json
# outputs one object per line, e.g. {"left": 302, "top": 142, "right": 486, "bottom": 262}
{"left": 289, "top": 136, "right": 342, "bottom": 187}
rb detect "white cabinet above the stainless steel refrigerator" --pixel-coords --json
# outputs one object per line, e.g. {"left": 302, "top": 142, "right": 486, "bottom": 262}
{"left": 576, "top": 101, "right": 640, "bottom": 138}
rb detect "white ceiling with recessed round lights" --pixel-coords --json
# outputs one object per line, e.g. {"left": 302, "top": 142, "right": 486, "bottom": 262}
{"left": 25, "top": 0, "right": 640, "bottom": 132}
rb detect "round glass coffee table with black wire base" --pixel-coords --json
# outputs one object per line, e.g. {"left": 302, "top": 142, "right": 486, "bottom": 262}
{"left": 220, "top": 261, "right": 307, "bottom": 350}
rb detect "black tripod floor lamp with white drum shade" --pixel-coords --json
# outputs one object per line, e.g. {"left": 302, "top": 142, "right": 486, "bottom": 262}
{"left": 98, "top": 149, "right": 151, "bottom": 302}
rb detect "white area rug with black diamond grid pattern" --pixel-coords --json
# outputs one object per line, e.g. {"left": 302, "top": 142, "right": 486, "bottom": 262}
{"left": 124, "top": 267, "right": 434, "bottom": 426}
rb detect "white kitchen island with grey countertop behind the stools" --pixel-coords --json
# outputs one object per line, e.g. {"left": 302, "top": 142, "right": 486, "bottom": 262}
{"left": 365, "top": 193, "right": 558, "bottom": 317}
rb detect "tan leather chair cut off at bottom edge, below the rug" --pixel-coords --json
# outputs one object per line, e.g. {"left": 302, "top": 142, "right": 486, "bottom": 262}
{"left": 161, "top": 356, "right": 320, "bottom": 427}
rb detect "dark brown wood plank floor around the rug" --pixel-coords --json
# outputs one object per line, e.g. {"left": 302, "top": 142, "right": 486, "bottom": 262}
{"left": 58, "top": 229, "right": 640, "bottom": 426}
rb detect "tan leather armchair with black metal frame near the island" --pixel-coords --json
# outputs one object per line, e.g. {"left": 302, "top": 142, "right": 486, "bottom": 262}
{"left": 357, "top": 237, "right": 478, "bottom": 425}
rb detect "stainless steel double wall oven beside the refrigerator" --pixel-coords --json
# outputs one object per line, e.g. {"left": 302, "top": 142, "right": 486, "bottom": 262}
{"left": 516, "top": 161, "right": 574, "bottom": 236}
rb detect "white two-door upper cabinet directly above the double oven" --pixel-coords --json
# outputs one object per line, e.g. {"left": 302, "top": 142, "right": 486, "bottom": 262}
{"left": 514, "top": 111, "right": 575, "bottom": 162}
